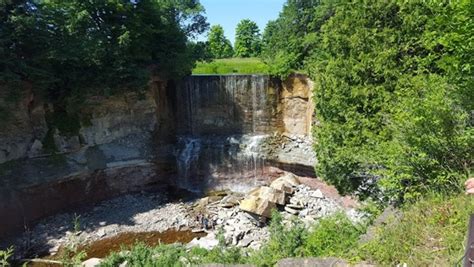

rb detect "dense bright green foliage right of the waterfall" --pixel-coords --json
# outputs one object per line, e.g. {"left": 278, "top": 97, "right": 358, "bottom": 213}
{"left": 264, "top": 0, "right": 474, "bottom": 200}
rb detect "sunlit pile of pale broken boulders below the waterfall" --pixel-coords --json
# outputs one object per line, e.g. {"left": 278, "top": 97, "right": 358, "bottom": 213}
{"left": 189, "top": 173, "right": 361, "bottom": 249}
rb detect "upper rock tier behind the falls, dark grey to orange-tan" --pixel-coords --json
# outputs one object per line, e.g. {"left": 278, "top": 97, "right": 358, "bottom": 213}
{"left": 176, "top": 75, "right": 314, "bottom": 136}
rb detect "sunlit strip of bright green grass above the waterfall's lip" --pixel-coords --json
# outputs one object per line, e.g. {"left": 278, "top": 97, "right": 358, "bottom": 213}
{"left": 193, "top": 58, "right": 269, "bottom": 74}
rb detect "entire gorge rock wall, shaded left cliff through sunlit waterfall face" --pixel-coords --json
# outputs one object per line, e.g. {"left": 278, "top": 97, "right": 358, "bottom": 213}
{"left": 0, "top": 75, "right": 315, "bottom": 239}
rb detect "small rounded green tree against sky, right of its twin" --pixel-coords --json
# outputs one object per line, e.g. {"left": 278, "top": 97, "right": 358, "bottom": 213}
{"left": 235, "top": 19, "right": 261, "bottom": 57}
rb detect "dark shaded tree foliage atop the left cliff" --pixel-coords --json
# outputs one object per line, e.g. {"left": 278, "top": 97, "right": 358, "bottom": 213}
{"left": 0, "top": 0, "right": 208, "bottom": 103}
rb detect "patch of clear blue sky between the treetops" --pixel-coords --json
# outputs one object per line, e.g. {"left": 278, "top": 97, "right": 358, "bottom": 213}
{"left": 199, "top": 0, "right": 286, "bottom": 43}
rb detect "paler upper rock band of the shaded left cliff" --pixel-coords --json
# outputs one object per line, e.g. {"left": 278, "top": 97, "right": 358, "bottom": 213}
{"left": 0, "top": 90, "right": 157, "bottom": 163}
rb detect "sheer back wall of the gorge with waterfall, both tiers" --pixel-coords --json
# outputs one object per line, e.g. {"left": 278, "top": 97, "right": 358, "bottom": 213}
{"left": 175, "top": 75, "right": 316, "bottom": 191}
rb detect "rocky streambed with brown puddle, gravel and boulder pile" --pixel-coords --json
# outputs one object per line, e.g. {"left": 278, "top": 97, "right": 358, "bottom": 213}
{"left": 1, "top": 172, "right": 362, "bottom": 264}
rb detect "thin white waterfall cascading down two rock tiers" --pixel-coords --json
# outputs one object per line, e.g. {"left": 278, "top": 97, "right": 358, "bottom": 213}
{"left": 177, "top": 75, "right": 278, "bottom": 191}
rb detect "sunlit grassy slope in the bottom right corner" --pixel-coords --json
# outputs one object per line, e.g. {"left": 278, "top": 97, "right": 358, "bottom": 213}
{"left": 354, "top": 195, "right": 474, "bottom": 266}
